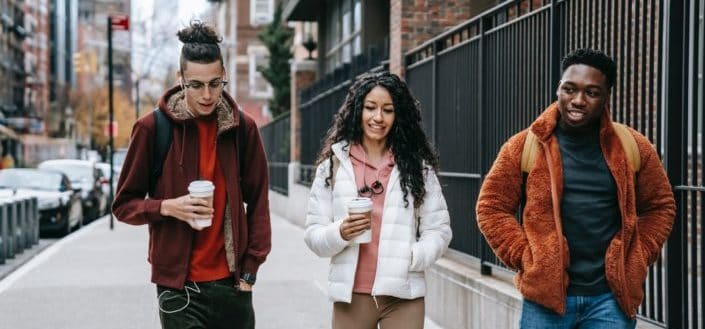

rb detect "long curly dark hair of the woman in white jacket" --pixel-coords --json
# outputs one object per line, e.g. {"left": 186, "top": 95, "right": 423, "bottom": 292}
{"left": 316, "top": 72, "right": 438, "bottom": 207}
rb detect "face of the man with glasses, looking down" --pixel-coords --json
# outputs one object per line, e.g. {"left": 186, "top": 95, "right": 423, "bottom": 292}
{"left": 179, "top": 61, "right": 224, "bottom": 116}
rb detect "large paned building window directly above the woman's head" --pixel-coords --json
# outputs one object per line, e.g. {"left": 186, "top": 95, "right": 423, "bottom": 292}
{"left": 325, "top": 0, "right": 362, "bottom": 72}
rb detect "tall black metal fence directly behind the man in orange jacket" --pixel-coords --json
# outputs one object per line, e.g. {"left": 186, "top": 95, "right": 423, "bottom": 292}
{"left": 406, "top": 0, "right": 705, "bottom": 328}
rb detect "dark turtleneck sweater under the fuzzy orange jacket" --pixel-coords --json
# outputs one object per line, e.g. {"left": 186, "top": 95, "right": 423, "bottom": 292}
{"left": 555, "top": 127, "right": 621, "bottom": 296}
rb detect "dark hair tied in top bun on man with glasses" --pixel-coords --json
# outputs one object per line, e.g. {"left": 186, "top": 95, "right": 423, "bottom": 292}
{"left": 176, "top": 20, "right": 223, "bottom": 74}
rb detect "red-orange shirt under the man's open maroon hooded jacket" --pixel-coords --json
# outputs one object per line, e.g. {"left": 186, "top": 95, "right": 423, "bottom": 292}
{"left": 188, "top": 115, "right": 230, "bottom": 282}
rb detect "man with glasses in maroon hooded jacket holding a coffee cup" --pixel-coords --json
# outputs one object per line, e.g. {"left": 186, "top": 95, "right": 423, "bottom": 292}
{"left": 113, "top": 21, "right": 271, "bottom": 329}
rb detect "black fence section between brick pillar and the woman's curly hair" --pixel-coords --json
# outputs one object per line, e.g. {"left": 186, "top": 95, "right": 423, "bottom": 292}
{"left": 297, "top": 47, "right": 388, "bottom": 185}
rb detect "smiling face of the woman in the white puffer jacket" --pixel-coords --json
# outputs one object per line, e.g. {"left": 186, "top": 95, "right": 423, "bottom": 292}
{"left": 362, "top": 86, "right": 394, "bottom": 145}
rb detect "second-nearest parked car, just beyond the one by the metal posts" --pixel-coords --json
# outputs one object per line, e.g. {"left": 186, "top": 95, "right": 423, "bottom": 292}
{"left": 37, "top": 159, "right": 108, "bottom": 220}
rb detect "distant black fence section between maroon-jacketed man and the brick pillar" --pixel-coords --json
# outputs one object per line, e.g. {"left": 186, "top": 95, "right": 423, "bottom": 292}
{"left": 260, "top": 113, "right": 291, "bottom": 195}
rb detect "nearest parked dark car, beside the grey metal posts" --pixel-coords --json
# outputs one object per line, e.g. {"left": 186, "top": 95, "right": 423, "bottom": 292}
{"left": 0, "top": 168, "right": 83, "bottom": 234}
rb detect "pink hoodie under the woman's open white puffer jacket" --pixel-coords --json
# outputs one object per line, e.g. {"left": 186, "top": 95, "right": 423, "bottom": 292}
{"left": 350, "top": 144, "right": 394, "bottom": 294}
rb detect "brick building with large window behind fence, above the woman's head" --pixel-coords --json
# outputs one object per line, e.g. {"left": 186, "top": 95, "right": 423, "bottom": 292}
{"left": 283, "top": 0, "right": 499, "bottom": 161}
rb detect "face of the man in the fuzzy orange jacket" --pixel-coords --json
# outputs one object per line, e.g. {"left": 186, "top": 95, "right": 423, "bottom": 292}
{"left": 556, "top": 64, "right": 610, "bottom": 132}
